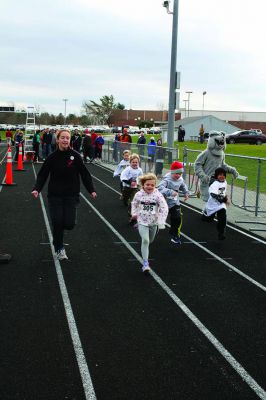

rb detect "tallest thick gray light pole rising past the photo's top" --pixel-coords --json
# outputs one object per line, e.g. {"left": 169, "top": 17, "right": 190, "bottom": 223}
{"left": 163, "top": 0, "right": 178, "bottom": 148}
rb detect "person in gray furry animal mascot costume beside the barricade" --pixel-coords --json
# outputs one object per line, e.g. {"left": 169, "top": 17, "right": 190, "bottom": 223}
{"left": 195, "top": 131, "right": 238, "bottom": 201}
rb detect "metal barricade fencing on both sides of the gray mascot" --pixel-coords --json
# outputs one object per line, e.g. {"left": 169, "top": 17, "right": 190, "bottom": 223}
{"left": 183, "top": 146, "right": 266, "bottom": 216}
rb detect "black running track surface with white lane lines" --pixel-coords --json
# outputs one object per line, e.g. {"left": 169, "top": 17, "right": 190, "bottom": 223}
{"left": 0, "top": 152, "right": 266, "bottom": 400}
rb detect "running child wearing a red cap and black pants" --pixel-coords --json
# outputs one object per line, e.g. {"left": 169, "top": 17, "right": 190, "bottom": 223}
{"left": 158, "top": 161, "right": 189, "bottom": 244}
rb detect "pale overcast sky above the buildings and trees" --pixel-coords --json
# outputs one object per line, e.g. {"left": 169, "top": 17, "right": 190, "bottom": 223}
{"left": 0, "top": 0, "right": 266, "bottom": 114}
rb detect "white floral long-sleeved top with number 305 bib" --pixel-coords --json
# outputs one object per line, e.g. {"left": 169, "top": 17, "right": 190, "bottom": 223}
{"left": 131, "top": 189, "right": 168, "bottom": 226}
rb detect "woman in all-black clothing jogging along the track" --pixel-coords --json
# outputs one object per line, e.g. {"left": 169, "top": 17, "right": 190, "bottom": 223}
{"left": 32, "top": 129, "right": 96, "bottom": 260}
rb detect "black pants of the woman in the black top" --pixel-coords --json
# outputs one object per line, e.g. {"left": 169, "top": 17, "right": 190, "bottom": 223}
{"left": 48, "top": 196, "right": 79, "bottom": 251}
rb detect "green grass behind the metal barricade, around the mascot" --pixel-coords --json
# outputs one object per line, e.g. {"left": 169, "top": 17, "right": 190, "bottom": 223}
{"left": 178, "top": 142, "right": 266, "bottom": 193}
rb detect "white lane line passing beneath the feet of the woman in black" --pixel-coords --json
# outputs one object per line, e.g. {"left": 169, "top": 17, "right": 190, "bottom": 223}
{"left": 32, "top": 165, "right": 96, "bottom": 400}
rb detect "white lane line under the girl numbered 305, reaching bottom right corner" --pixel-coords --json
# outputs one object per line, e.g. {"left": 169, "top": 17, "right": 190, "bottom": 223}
{"left": 81, "top": 193, "right": 266, "bottom": 400}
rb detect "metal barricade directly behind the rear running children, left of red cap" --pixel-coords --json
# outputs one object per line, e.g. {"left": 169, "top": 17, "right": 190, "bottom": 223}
{"left": 102, "top": 141, "right": 179, "bottom": 176}
